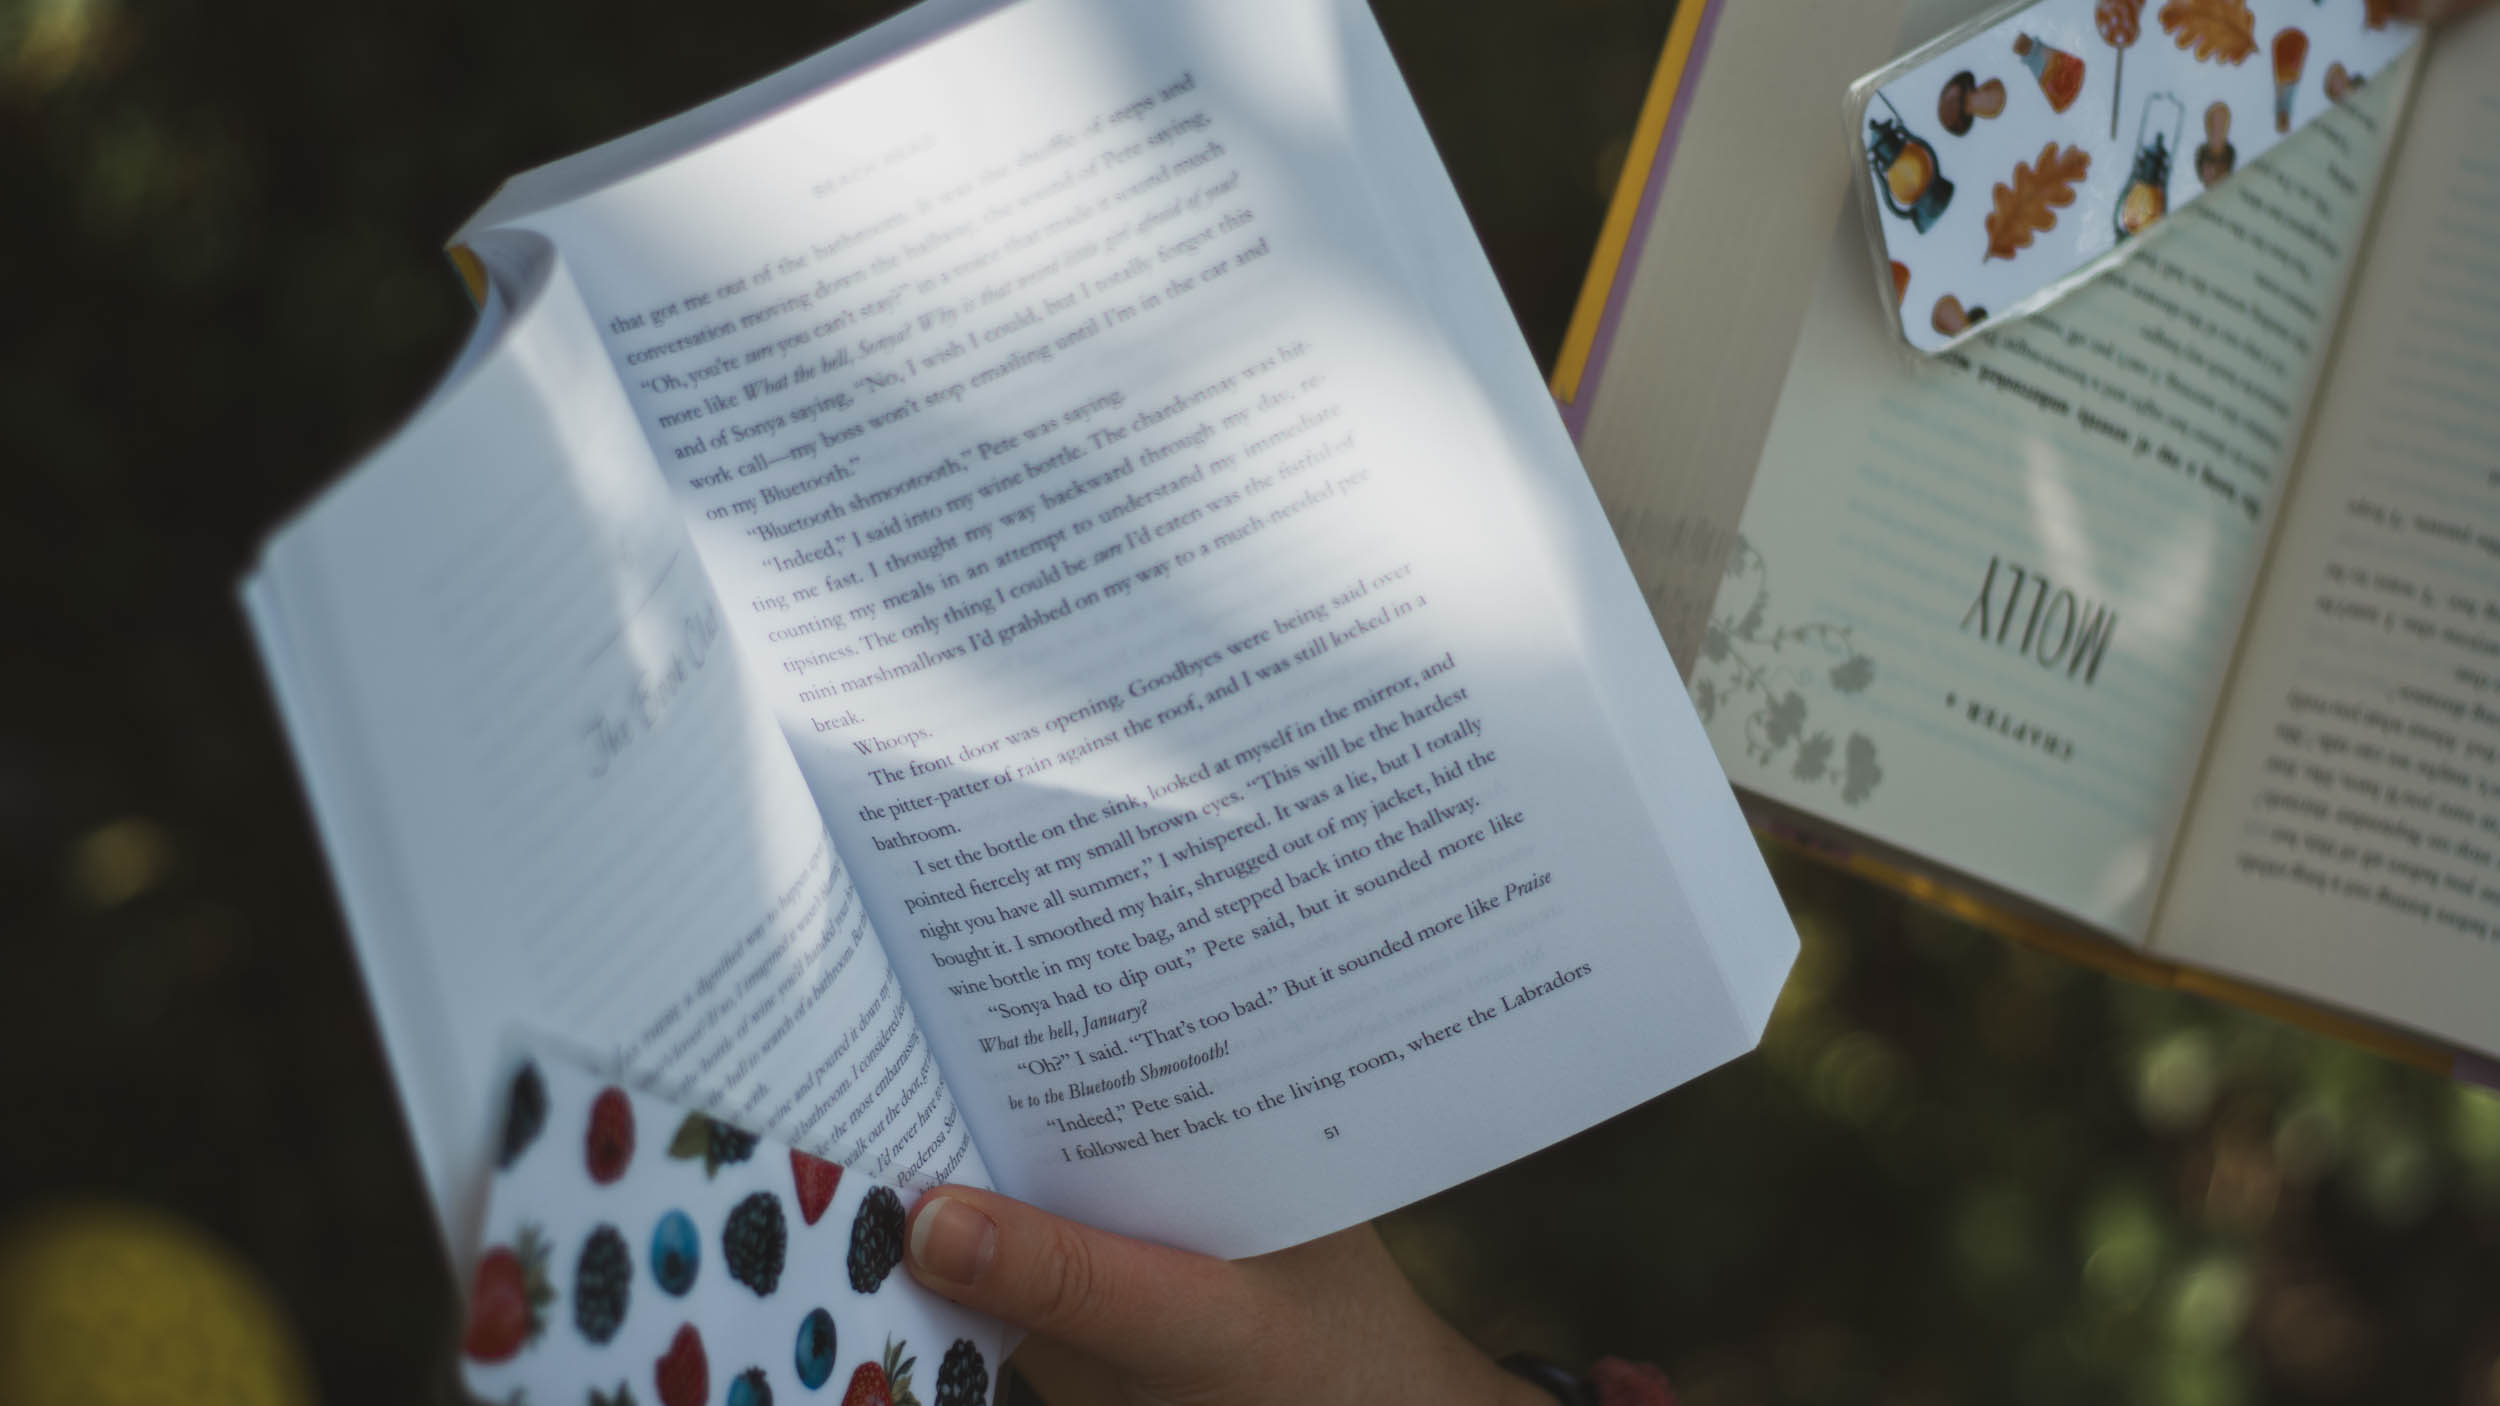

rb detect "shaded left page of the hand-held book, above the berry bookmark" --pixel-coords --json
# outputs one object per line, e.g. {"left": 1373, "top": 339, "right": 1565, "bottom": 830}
{"left": 248, "top": 243, "right": 983, "bottom": 1246}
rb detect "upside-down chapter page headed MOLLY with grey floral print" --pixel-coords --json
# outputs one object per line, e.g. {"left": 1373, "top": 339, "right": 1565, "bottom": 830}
{"left": 1693, "top": 35, "right": 2400, "bottom": 941}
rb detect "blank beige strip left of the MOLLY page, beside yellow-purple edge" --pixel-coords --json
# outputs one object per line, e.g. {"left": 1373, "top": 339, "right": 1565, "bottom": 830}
{"left": 1573, "top": 0, "right": 1920, "bottom": 673}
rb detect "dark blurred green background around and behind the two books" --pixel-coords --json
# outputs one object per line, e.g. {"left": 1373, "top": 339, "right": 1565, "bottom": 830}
{"left": 0, "top": 0, "right": 2500, "bottom": 1406}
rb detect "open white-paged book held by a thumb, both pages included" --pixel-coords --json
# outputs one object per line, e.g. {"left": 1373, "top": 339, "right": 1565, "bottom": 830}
{"left": 248, "top": 0, "right": 1795, "bottom": 1256}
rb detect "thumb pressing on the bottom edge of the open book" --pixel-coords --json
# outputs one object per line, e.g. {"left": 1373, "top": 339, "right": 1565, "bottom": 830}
{"left": 908, "top": 1186, "right": 1250, "bottom": 1378}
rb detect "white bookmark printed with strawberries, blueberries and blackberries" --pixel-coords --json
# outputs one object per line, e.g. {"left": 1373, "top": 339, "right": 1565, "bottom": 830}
{"left": 460, "top": 1056, "right": 1010, "bottom": 1406}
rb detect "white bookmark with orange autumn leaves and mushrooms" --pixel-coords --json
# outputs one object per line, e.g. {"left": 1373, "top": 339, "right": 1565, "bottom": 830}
{"left": 1850, "top": 0, "right": 2420, "bottom": 353}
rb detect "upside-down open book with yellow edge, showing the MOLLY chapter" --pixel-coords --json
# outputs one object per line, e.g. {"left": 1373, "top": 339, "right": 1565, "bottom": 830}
{"left": 1555, "top": 0, "right": 2500, "bottom": 1073}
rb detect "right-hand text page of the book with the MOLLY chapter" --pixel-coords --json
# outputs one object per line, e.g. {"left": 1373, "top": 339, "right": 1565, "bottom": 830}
{"left": 2155, "top": 13, "right": 2500, "bottom": 1051}
